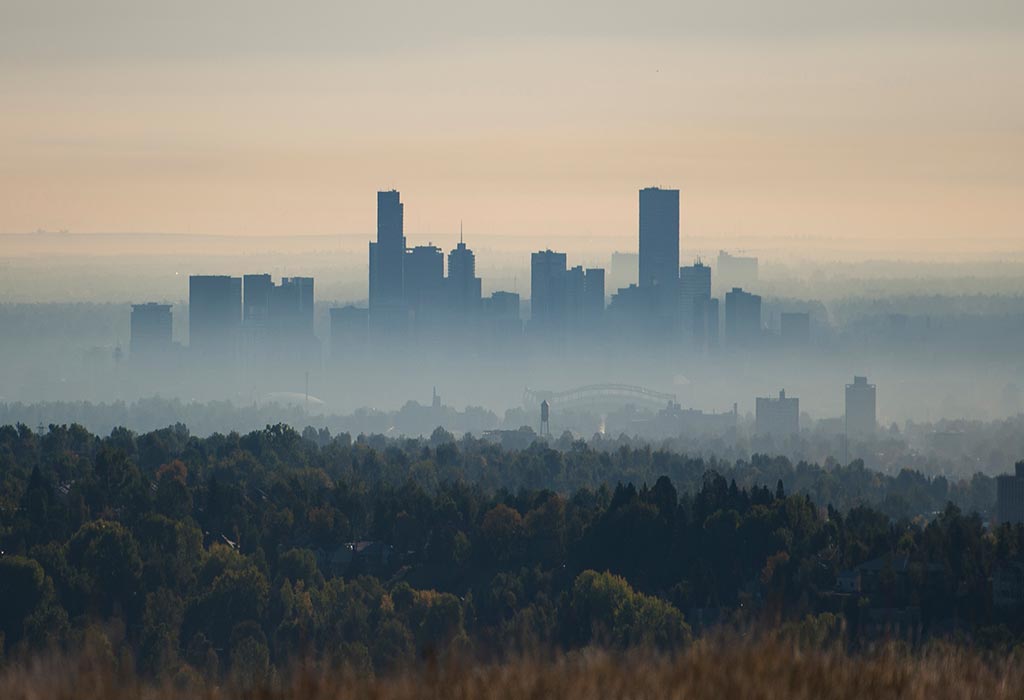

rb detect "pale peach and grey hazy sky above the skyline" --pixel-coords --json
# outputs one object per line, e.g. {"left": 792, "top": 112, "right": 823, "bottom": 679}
{"left": 0, "top": 0, "right": 1024, "bottom": 258}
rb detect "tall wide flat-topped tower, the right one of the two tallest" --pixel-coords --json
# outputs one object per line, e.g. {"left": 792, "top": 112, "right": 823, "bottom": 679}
{"left": 639, "top": 187, "right": 679, "bottom": 298}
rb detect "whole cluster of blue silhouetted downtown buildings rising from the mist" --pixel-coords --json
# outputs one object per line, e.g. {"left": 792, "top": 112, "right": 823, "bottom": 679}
{"left": 131, "top": 187, "right": 810, "bottom": 364}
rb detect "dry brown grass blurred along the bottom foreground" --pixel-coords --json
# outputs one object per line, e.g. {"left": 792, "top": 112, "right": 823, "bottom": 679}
{"left": 0, "top": 642, "right": 1024, "bottom": 700}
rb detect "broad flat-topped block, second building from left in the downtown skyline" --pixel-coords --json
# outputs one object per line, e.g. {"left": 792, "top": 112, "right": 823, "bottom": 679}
{"left": 188, "top": 274, "right": 242, "bottom": 359}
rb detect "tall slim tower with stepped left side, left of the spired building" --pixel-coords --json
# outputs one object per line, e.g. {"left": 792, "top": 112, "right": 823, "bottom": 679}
{"left": 370, "top": 189, "right": 408, "bottom": 333}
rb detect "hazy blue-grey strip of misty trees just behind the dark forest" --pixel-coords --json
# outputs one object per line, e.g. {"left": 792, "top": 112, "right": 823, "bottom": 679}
{"left": 0, "top": 398, "right": 1024, "bottom": 479}
